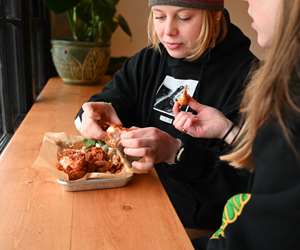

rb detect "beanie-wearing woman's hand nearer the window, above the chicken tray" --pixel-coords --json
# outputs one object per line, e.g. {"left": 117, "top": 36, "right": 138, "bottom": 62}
{"left": 79, "top": 102, "right": 122, "bottom": 140}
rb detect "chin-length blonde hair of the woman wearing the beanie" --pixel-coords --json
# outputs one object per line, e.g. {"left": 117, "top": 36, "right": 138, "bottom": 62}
{"left": 148, "top": 10, "right": 228, "bottom": 61}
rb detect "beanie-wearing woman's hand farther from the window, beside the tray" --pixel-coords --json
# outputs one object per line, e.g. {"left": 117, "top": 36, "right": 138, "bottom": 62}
{"left": 121, "top": 127, "right": 181, "bottom": 170}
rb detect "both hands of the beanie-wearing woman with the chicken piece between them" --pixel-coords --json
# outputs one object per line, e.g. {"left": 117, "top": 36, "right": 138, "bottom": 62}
{"left": 80, "top": 102, "right": 180, "bottom": 170}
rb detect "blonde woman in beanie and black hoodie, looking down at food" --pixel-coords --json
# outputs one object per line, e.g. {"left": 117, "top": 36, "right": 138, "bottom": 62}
{"left": 76, "top": 0, "right": 254, "bottom": 230}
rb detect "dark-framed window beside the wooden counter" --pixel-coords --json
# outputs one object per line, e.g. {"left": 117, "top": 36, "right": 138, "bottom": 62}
{"left": 0, "top": 0, "right": 54, "bottom": 152}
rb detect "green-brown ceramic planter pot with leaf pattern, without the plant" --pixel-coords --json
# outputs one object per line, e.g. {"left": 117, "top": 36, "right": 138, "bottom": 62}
{"left": 51, "top": 40, "right": 110, "bottom": 84}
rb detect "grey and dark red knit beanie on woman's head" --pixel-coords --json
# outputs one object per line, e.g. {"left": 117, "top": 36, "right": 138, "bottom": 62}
{"left": 149, "top": 0, "right": 224, "bottom": 10}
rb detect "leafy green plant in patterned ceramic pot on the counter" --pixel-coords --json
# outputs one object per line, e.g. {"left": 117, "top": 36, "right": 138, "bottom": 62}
{"left": 47, "top": 0, "right": 131, "bottom": 84}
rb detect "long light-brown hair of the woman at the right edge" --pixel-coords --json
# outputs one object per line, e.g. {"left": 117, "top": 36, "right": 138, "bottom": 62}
{"left": 221, "top": 0, "right": 300, "bottom": 170}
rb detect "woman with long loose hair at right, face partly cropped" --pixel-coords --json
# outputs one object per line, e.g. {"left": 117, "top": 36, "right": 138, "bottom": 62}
{"left": 174, "top": 0, "right": 300, "bottom": 250}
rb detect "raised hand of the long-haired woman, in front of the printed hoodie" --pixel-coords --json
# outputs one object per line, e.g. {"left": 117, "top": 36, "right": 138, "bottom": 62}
{"left": 173, "top": 98, "right": 232, "bottom": 139}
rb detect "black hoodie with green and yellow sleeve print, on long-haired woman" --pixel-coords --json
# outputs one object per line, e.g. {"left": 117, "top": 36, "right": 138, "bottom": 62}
{"left": 207, "top": 67, "right": 300, "bottom": 250}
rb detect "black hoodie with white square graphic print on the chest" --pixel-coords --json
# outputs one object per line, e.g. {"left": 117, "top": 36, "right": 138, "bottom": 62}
{"left": 77, "top": 20, "right": 255, "bottom": 228}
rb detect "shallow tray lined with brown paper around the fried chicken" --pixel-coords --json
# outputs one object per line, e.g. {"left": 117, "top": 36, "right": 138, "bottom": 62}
{"left": 33, "top": 132, "right": 145, "bottom": 191}
